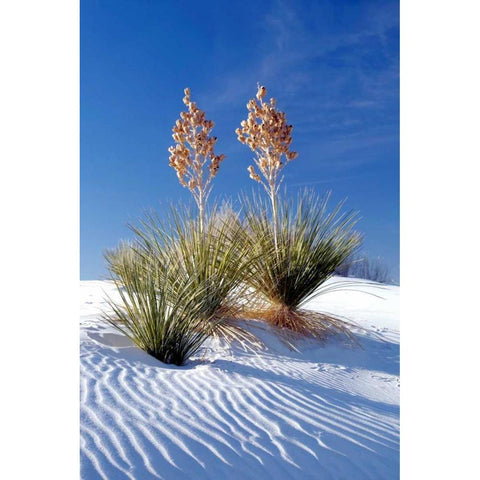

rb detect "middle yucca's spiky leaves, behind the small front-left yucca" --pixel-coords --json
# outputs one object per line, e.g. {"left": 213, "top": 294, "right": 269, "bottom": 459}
{"left": 123, "top": 205, "right": 260, "bottom": 348}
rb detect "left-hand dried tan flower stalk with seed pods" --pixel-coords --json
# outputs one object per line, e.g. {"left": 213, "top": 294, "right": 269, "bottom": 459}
{"left": 168, "top": 88, "right": 225, "bottom": 232}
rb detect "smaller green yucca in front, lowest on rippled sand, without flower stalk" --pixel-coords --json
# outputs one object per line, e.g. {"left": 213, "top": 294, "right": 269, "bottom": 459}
{"left": 103, "top": 246, "right": 222, "bottom": 365}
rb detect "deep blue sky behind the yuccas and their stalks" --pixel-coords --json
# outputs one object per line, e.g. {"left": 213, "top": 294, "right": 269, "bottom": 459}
{"left": 80, "top": 0, "right": 399, "bottom": 281}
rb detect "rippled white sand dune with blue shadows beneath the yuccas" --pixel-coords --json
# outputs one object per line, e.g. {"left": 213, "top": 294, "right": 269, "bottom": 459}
{"left": 80, "top": 280, "right": 399, "bottom": 480}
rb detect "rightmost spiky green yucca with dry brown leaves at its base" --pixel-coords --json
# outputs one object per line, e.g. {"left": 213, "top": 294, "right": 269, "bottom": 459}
{"left": 238, "top": 192, "right": 360, "bottom": 344}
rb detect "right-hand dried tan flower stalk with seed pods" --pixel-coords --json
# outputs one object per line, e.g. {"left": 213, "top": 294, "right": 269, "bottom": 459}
{"left": 235, "top": 85, "right": 298, "bottom": 249}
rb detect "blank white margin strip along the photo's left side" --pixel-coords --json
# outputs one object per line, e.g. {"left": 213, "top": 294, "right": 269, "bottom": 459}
{"left": 0, "top": 0, "right": 79, "bottom": 479}
